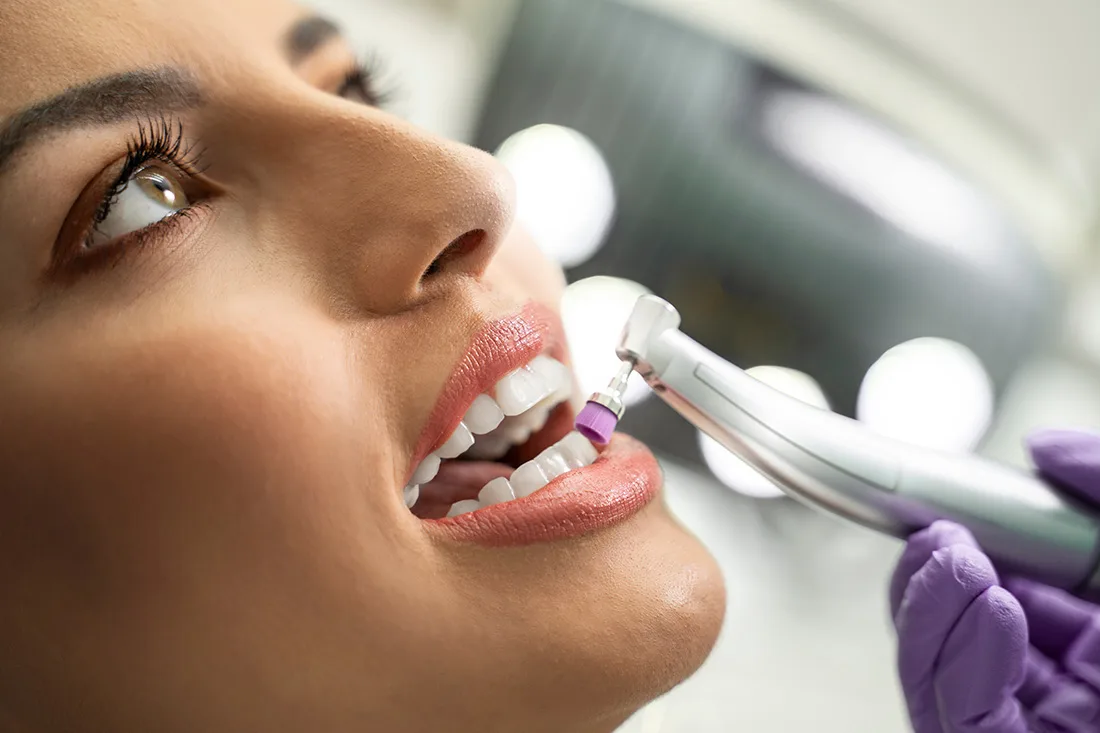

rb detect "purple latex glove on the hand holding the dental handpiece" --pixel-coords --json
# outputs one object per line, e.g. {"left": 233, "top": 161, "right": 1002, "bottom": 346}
{"left": 890, "top": 430, "right": 1100, "bottom": 733}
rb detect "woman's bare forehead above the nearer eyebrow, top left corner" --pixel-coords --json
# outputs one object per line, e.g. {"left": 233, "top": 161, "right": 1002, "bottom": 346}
{"left": 0, "top": 0, "right": 305, "bottom": 119}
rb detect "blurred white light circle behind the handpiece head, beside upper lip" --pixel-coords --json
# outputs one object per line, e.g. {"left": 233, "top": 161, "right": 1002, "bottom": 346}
{"left": 561, "top": 276, "right": 650, "bottom": 406}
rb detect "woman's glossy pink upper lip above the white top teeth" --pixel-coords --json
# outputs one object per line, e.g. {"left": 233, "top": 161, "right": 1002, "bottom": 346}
{"left": 410, "top": 302, "right": 565, "bottom": 470}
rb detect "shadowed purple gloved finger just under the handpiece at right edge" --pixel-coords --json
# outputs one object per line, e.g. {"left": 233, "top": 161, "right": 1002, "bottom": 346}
{"left": 1007, "top": 578, "right": 1100, "bottom": 691}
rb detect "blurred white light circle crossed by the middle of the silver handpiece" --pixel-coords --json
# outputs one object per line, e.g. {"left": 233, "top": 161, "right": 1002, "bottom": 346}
{"left": 699, "top": 365, "right": 828, "bottom": 499}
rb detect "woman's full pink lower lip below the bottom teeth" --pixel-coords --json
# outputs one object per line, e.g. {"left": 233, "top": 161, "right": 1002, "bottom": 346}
{"left": 424, "top": 435, "right": 661, "bottom": 547}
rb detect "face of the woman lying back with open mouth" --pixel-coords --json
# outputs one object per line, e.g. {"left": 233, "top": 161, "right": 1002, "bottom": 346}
{"left": 0, "top": 0, "right": 724, "bottom": 733}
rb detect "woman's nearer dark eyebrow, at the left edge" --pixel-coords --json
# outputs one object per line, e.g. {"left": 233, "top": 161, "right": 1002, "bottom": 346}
{"left": 0, "top": 67, "right": 202, "bottom": 173}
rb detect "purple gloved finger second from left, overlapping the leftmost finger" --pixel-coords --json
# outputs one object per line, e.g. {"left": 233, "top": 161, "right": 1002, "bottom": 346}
{"left": 935, "top": 586, "right": 1027, "bottom": 733}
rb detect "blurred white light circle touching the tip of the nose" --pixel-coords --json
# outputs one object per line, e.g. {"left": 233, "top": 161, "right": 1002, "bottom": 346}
{"left": 496, "top": 124, "right": 615, "bottom": 267}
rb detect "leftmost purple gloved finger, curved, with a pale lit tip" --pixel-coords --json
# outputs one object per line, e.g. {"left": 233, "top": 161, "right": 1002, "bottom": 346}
{"left": 894, "top": 544, "right": 998, "bottom": 733}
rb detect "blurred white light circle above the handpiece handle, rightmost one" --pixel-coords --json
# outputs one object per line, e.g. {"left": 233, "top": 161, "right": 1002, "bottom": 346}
{"left": 856, "top": 338, "right": 993, "bottom": 450}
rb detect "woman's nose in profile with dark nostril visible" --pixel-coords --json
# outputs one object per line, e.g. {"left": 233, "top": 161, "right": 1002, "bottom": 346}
{"left": 244, "top": 99, "right": 515, "bottom": 314}
